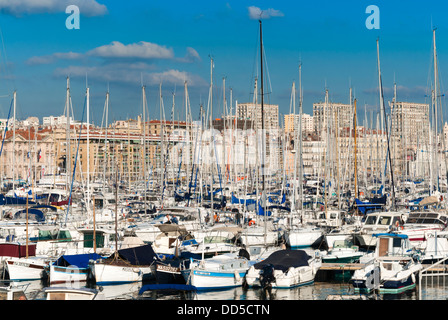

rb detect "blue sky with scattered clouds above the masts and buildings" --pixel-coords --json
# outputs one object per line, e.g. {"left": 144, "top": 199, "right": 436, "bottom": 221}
{"left": 0, "top": 0, "right": 448, "bottom": 124}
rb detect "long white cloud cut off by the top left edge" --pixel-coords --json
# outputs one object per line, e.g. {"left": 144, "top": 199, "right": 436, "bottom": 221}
{"left": 0, "top": 0, "right": 107, "bottom": 16}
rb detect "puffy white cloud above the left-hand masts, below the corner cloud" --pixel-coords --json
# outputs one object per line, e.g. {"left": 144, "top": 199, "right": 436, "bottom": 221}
{"left": 87, "top": 41, "right": 174, "bottom": 59}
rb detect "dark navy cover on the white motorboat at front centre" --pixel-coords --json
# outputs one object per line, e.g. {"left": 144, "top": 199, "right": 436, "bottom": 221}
{"left": 254, "top": 249, "right": 311, "bottom": 272}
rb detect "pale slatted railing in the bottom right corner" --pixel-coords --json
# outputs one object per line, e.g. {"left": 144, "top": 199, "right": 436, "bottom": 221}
{"left": 418, "top": 257, "right": 448, "bottom": 300}
